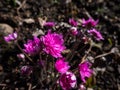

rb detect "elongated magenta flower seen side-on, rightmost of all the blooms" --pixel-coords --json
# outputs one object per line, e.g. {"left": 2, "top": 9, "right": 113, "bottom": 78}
{"left": 88, "top": 29, "right": 104, "bottom": 41}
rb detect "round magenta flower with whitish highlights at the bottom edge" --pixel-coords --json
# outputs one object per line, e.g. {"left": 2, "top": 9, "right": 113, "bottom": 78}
{"left": 59, "top": 72, "right": 76, "bottom": 90}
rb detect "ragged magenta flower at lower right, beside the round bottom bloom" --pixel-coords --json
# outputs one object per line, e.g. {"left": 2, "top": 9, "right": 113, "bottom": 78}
{"left": 79, "top": 61, "right": 93, "bottom": 83}
